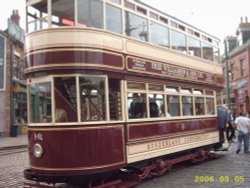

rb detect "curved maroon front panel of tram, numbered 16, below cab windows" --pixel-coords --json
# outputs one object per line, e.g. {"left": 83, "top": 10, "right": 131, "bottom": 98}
{"left": 28, "top": 125, "right": 125, "bottom": 175}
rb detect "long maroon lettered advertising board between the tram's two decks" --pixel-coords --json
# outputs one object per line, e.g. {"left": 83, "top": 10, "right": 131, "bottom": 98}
{"left": 127, "top": 58, "right": 215, "bottom": 83}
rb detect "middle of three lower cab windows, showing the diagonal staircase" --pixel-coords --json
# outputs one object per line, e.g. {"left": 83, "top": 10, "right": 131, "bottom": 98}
{"left": 54, "top": 77, "right": 77, "bottom": 122}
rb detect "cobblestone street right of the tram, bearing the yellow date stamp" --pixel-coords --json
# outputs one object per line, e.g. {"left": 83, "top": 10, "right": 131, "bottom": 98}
{"left": 137, "top": 144, "right": 250, "bottom": 188}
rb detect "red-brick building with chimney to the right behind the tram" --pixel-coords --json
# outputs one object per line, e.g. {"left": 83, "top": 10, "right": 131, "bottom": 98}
{"left": 224, "top": 18, "right": 250, "bottom": 113}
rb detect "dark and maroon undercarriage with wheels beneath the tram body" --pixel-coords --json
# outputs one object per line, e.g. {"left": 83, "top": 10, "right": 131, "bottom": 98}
{"left": 24, "top": 147, "right": 223, "bottom": 188}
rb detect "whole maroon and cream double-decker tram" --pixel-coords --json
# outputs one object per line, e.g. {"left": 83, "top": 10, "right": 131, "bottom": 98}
{"left": 24, "top": 0, "right": 223, "bottom": 187}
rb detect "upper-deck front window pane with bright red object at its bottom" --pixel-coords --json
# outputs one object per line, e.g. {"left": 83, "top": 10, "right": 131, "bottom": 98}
{"left": 52, "top": 0, "right": 75, "bottom": 27}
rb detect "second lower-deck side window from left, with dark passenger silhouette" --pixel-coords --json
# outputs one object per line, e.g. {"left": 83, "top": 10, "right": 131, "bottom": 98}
{"left": 148, "top": 94, "right": 165, "bottom": 118}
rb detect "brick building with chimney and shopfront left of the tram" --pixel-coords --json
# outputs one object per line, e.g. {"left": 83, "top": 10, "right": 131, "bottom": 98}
{"left": 0, "top": 10, "right": 27, "bottom": 136}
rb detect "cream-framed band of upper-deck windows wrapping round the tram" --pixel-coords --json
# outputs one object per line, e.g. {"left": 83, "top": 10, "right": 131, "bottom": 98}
{"left": 26, "top": 0, "right": 220, "bottom": 63}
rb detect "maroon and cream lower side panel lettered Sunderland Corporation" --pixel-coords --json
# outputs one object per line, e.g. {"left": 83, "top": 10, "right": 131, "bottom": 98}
{"left": 126, "top": 118, "right": 219, "bottom": 163}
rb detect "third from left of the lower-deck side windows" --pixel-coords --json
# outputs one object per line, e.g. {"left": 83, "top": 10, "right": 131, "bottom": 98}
{"left": 167, "top": 95, "right": 180, "bottom": 117}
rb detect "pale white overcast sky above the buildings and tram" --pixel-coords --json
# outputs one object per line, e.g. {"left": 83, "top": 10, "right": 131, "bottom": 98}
{"left": 0, "top": 0, "right": 250, "bottom": 51}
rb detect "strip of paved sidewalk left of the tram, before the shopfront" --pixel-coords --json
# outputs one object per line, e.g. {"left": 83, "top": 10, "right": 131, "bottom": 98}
{"left": 0, "top": 134, "right": 28, "bottom": 150}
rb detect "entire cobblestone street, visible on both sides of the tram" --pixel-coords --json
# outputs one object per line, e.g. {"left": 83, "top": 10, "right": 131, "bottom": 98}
{"left": 0, "top": 144, "right": 250, "bottom": 188}
